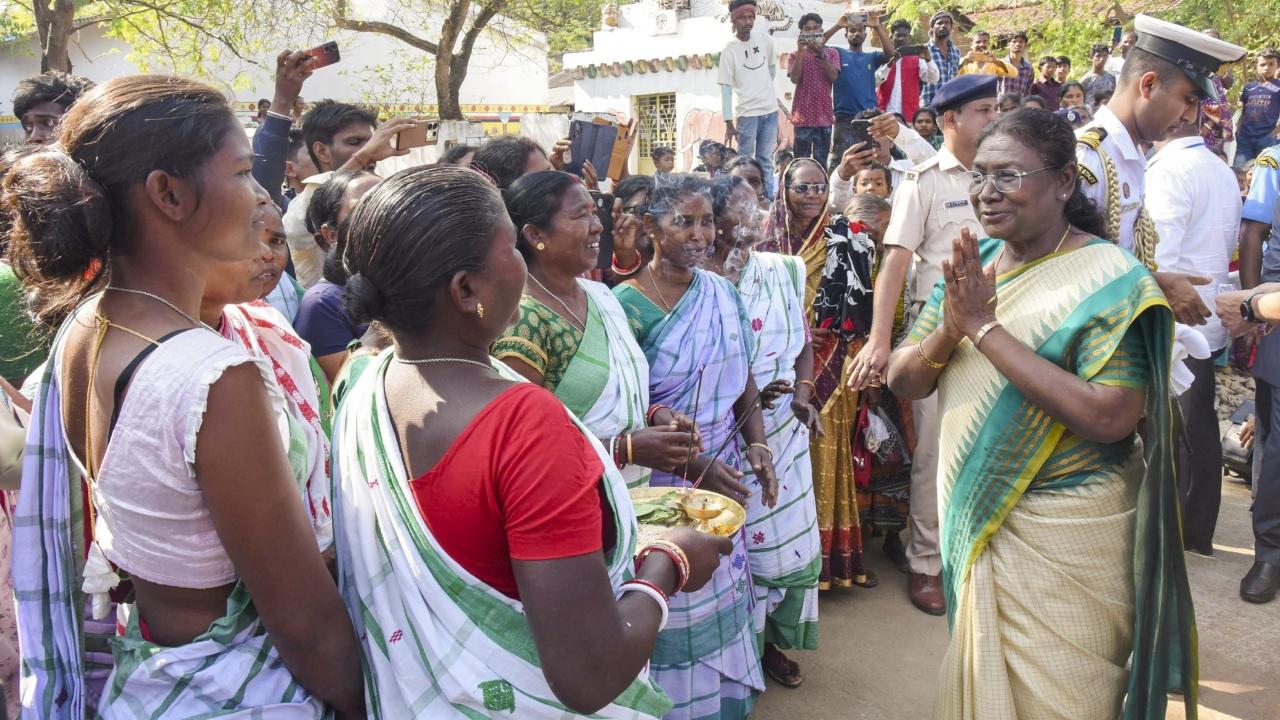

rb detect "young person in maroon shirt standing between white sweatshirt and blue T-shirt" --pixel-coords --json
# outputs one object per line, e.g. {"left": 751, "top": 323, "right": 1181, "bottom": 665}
{"left": 787, "top": 13, "right": 841, "bottom": 165}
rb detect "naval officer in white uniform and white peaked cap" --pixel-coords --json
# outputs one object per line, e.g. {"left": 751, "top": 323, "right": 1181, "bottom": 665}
{"left": 1076, "top": 15, "right": 1244, "bottom": 325}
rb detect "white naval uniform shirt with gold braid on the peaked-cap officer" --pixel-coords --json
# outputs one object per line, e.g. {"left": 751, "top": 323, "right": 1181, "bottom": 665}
{"left": 1075, "top": 105, "right": 1147, "bottom": 252}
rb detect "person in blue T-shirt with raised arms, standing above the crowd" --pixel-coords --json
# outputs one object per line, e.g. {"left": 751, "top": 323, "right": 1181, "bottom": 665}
{"left": 827, "top": 13, "right": 892, "bottom": 167}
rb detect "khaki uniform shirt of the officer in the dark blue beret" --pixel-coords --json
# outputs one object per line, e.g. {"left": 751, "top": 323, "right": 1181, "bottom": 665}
{"left": 884, "top": 146, "right": 984, "bottom": 304}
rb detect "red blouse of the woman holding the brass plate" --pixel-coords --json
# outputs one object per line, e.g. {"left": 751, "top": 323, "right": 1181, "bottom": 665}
{"left": 410, "top": 383, "right": 612, "bottom": 600}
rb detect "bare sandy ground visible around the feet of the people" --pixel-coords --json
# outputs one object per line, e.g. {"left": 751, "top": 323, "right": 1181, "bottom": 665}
{"left": 753, "top": 471, "right": 1280, "bottom": 720}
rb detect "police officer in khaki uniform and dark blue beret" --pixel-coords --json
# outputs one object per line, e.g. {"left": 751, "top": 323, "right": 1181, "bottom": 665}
{"left": 849, "top": 74, "right": 996, "bottom": 615}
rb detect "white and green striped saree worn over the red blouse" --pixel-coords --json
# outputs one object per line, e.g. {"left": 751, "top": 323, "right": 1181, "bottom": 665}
{"left": 334, "top": 350, "right": 671, "bottom": 720}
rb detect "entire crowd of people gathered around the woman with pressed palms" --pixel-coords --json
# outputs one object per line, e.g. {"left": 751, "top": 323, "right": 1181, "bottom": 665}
{"left": 0, "top": 0, "right": 1280, "bottom": 720}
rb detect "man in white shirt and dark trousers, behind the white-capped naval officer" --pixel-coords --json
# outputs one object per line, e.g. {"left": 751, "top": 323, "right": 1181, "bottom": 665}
{"left": 1147, "top": 123, "right": 1242, "bottom": 555}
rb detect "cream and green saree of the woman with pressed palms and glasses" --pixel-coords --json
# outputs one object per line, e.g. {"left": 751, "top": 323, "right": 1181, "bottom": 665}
{"left": 909, "top": 240, "right": 1197, "bottom": 720}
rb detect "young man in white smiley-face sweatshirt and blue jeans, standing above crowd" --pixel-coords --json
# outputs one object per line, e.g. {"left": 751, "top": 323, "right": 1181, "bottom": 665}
{"left": 719, "top": 0, "right": 778, "bottom": 197}
